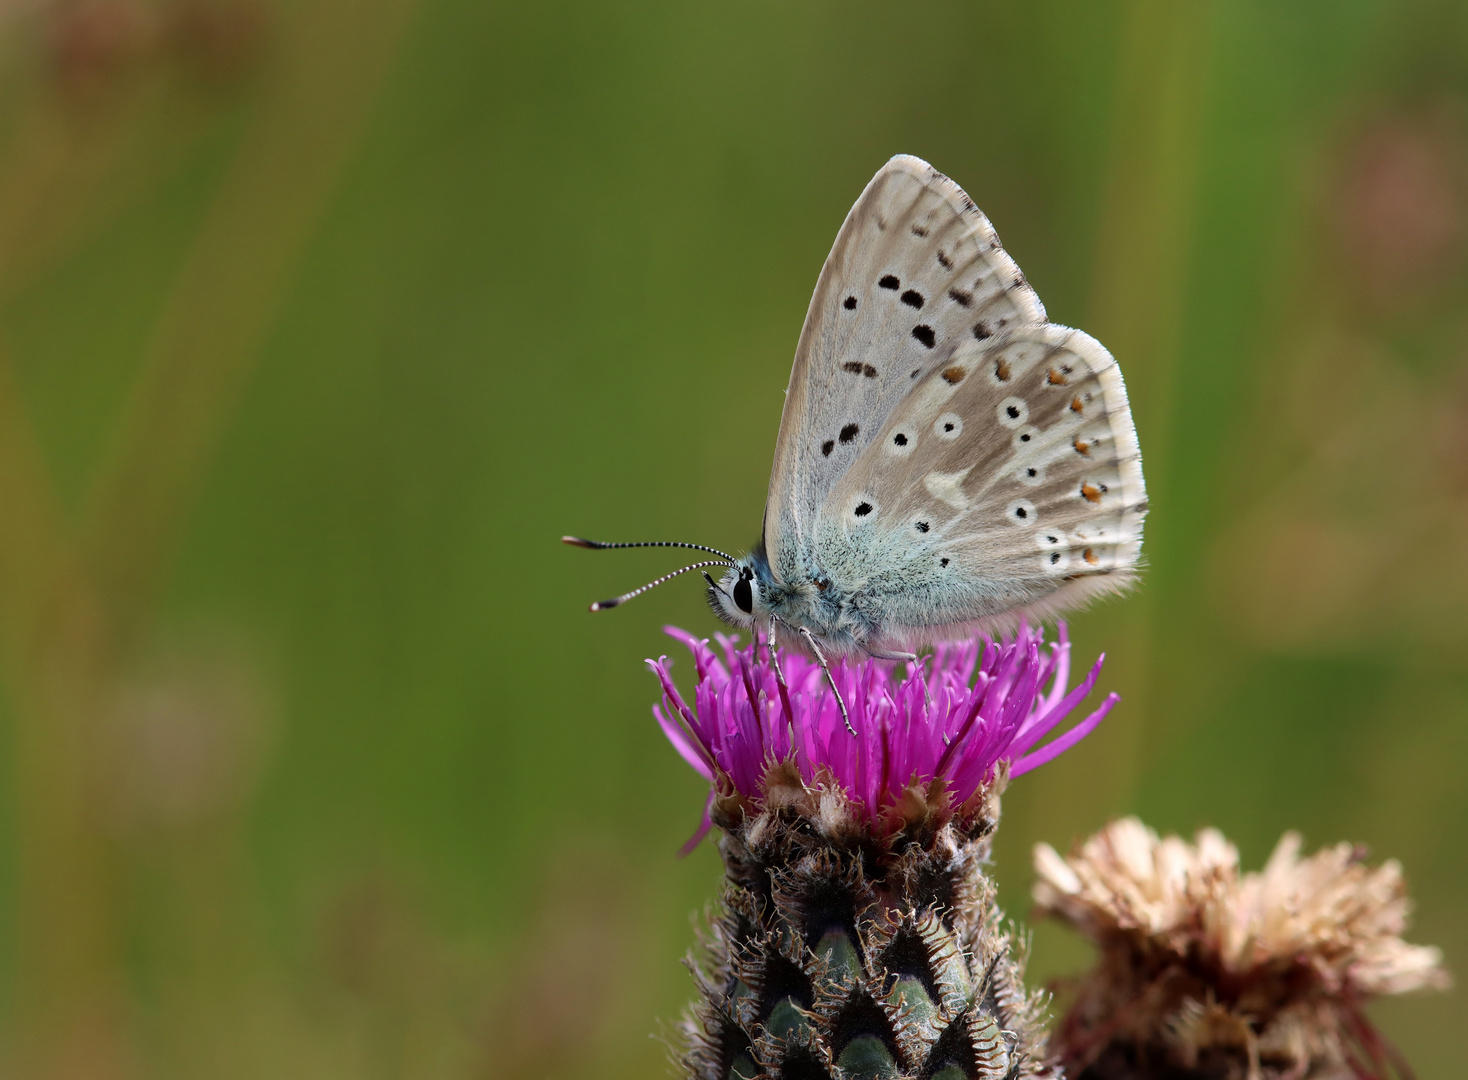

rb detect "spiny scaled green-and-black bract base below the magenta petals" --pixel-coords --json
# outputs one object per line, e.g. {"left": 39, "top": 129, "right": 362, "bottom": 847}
{"left": 683, "top": 776, "right": 1055, "bottom": 1080}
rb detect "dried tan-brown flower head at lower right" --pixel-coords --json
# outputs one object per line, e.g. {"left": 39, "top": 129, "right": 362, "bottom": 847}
{"left": 1033, "top": 817, "right": 1447, "bottom": 1080}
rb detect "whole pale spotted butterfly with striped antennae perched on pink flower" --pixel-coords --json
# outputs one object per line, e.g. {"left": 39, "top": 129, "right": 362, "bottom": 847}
{"left": 564, "top": 154, "right": 1147, "bottom": 724}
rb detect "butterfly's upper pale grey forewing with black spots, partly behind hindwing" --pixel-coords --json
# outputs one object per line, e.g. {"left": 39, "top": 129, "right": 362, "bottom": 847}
{"left": 763, "top": 156, "right": 1045, "bottom": 581}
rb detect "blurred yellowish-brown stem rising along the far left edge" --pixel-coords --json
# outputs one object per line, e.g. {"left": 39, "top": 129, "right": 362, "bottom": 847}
{"left": 0, "top": 360, "right": 126, "bottom": 1080}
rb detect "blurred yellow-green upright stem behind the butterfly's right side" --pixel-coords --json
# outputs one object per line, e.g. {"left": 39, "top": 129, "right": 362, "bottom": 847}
{"left": 1022, "top": 0, "right": 1211, "bottom": 839}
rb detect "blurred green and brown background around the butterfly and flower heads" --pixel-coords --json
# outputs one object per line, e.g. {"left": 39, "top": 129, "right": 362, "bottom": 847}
{"left": 0, "top": 0, "right": 1468, "bottom": 1080}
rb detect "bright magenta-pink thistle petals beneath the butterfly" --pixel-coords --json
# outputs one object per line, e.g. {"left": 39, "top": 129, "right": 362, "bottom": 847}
{"left": 647, "top": 624, "right": 1120, "bottom": 851}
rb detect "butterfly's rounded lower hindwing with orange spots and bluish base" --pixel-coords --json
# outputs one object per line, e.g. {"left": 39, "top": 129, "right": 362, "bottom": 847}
{"left": 815, "top": 324, "right": 1147, "bottom": 644}
